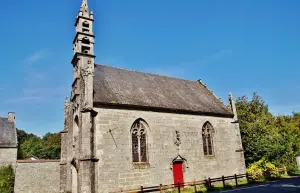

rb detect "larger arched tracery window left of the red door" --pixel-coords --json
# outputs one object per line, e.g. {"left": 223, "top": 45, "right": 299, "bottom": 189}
{"left": 131, "top": 119, "right": 148, "bottom": 162}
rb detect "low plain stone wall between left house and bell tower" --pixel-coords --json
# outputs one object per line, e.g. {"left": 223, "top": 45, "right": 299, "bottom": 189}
{"left": 14, "top": 160, "right": 60, "bottom": 193}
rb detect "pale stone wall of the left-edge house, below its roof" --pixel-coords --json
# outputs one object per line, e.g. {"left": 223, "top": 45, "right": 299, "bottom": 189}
{"left": 0, "top": 148, "right": 18, "bottom": 167}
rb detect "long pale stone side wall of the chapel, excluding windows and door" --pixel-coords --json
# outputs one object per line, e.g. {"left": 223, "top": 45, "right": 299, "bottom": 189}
{"left": 94, "top": 108, "right": 246, "bottom": 192}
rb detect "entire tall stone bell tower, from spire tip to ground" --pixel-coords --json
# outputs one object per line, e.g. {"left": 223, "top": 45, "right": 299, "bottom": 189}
{"left": 66, "top": 0, "right": 97, "bottom": 193}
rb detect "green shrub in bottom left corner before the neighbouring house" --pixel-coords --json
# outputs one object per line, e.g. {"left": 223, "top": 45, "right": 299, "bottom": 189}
{"left": 0, "top": 165, "right": 15, "bottom": 193}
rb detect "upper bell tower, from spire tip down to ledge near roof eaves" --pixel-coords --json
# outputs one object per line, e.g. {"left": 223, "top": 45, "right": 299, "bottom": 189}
{"left": 71, "top": 0, "right": 96, "bottom": 111}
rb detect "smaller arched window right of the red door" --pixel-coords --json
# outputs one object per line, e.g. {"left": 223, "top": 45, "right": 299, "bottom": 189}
{"left": 202, "top": 122, "right": 214, "bottom": 156}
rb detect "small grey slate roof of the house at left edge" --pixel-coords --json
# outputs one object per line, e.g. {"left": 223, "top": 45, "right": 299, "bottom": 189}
{"left": 0, "top": 117, "right": 17, "bottom": 147}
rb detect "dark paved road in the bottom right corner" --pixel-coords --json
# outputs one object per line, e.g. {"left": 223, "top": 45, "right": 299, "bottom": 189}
{"left": 214, "top": 177, "right": 300, "bottom": 193}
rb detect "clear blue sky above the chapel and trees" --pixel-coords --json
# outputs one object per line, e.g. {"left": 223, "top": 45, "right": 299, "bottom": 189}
{"left": 0, "top": 0, "right": 300, "bottom": 135}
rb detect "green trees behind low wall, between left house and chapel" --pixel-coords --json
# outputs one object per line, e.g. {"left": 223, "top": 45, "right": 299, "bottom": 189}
{"left": 18, "top": 130, "right": 60, "bottom": 159}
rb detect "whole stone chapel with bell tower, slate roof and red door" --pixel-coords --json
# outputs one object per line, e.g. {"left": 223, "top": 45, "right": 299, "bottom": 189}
{"left": 60, "top": 0, "right": 246, "bottom": 193}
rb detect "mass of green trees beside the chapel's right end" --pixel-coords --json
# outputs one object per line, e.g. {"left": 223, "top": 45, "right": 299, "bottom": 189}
{"left": 236, "top": 93, "right": 300, "bottom": 172}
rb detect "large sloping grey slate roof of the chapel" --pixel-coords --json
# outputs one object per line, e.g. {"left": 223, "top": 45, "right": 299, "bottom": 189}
{"left": 94, "top": 65, "right": 233, "bottom": 117}
